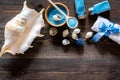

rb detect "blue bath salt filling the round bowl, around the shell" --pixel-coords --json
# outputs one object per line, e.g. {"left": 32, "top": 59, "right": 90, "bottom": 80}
{"left": 47, "top": 5, "right": 67, "bottom": 25}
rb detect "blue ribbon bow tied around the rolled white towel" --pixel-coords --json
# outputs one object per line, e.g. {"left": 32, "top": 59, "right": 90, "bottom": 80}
{"left": 92, "top": 22, "right": 120, "bottom": 43}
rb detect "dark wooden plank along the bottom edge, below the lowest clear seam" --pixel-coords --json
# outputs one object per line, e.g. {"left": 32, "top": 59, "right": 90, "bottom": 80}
{"left": 0, "top": 59, "right": 120, "bottom": 80}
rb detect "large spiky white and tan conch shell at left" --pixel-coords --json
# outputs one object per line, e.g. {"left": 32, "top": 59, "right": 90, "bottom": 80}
{"left": 0, "top": 1, "right": 45, "bottom": 56}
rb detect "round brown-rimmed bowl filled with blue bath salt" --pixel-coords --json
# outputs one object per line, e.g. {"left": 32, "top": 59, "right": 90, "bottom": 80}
{"left": 45, "top": 3, "right": 69, "bottom": 27}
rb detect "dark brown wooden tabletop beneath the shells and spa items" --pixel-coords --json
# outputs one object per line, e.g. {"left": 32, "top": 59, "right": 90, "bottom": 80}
{"left": 0, "top": 0, "right": 120, "bottom": 80}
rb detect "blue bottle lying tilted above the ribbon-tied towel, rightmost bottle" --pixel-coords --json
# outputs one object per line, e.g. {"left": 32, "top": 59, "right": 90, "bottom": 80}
{"left": 88, "top": 0, "right": 110, "bottom": 15}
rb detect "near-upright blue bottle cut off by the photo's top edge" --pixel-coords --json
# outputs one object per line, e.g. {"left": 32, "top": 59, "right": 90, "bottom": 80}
{"left": 75, "top": 0, "right": 85, "bottom": 19}
